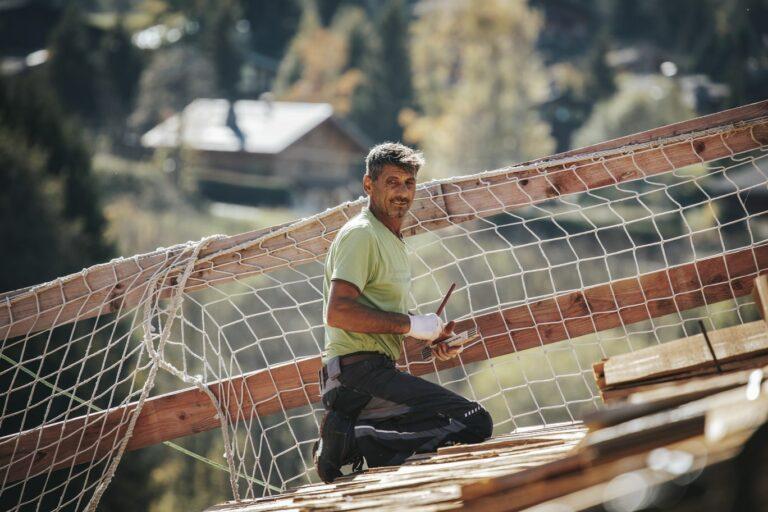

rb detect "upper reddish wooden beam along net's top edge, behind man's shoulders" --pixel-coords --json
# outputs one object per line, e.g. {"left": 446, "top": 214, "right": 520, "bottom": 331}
{"left": 0, "top": 101, "right": 768, "bottom": 339}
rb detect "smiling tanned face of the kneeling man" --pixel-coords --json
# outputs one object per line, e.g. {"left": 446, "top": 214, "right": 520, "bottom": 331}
{"left": 363, "top": 164, "right": 416, "bottom": 219}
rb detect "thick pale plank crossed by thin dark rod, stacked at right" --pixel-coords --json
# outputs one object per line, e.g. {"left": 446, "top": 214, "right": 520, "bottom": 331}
{"left": 603, "top": 320, "right": 768, "bottom": 386}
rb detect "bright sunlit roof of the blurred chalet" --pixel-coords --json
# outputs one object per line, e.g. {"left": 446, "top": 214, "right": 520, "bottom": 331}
{"left": 141, "top": 98, "right": 365, "bottom": 154}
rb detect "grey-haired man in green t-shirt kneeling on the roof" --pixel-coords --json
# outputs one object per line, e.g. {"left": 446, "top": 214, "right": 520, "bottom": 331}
{"left": 315, "top": 143, "right": 493, "bottom": 483}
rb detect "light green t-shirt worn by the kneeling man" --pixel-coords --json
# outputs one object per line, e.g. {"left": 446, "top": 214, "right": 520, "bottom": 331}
{"left": 323, "top": 208, "right": 411, "bottom": 362}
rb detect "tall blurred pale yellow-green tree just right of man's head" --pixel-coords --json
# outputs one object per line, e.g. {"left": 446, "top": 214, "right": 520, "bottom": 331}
{"left": 404, "top": 0, "right": 554, "bottom": 176}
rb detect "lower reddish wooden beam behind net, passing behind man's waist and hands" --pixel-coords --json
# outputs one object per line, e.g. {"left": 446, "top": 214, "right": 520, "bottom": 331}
{"left": 0, "top": 245, "right": 768, "bottom": 480}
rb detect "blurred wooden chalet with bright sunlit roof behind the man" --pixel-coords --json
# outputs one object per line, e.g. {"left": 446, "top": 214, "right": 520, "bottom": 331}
{"left": 146, "top": 99, "right": 368, "bottom": 206}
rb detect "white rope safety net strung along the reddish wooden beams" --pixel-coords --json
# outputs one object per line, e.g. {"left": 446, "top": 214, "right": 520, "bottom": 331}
{"left": 0, "top": 114, "right": 768, "bottom": 510}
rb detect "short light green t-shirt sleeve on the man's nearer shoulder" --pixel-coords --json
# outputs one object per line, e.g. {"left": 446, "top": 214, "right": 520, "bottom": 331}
{"left": 331, "top": 229, "right": 375, "bottom": 292}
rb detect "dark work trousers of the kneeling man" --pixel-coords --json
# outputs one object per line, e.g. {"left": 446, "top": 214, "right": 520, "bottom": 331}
{"left": 323, "top": 355, "right": 493, "bottom": 467}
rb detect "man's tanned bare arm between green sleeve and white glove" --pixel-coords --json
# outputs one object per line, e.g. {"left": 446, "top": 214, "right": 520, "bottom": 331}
{"left": 325, "top": 279, "right": 411, "bottom": 334}
